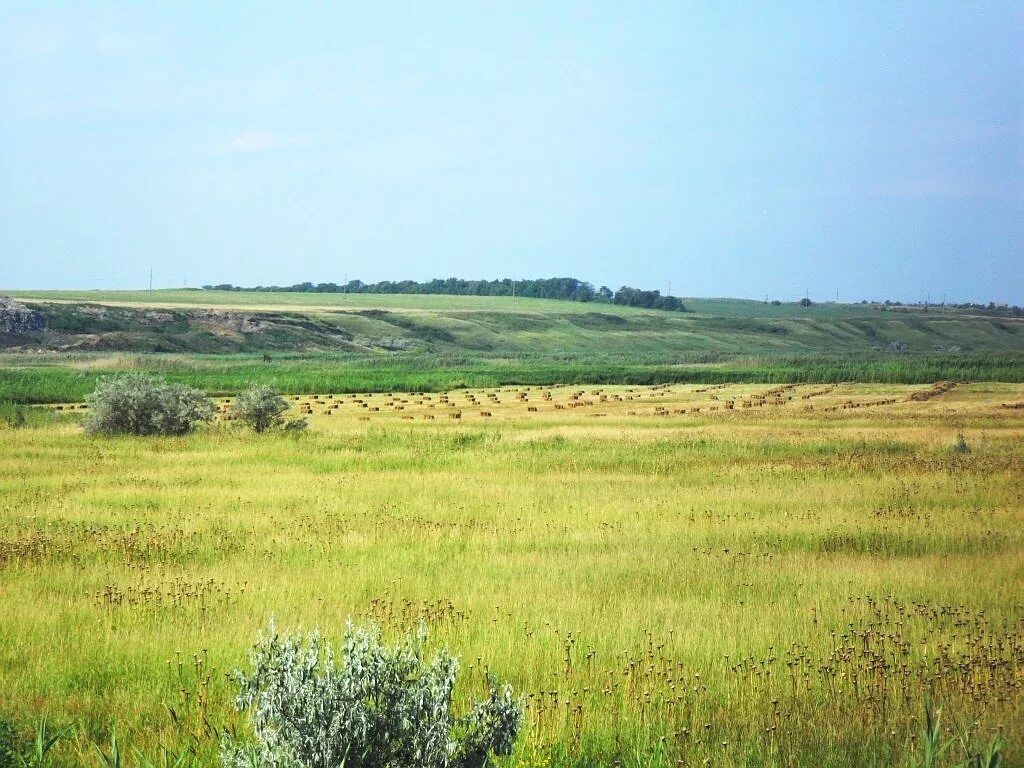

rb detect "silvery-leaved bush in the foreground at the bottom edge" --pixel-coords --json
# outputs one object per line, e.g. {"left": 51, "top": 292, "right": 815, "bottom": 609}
{"left": 221, "top": 623, "right": 522, "bottom": 768}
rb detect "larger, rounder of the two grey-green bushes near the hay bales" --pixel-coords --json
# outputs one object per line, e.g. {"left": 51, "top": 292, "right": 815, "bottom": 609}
{"left": 85, "top": 373, "right": 214, "bottom": 435}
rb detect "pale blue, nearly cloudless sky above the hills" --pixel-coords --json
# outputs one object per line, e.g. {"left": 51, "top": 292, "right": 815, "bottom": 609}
{"left": 0, "top": 0, "right": 1024, "bottom": 304}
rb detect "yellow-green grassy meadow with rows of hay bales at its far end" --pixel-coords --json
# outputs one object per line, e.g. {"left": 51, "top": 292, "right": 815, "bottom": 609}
{"left": 0, "top": 384, "right": 1024, "bottom": 766}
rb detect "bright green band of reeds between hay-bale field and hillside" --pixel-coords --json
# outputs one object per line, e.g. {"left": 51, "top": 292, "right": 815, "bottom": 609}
{"left": 0, "top": 355, "right": 1024, "bottom": 403}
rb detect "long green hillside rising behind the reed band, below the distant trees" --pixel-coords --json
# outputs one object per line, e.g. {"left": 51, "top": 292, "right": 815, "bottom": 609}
{"left": 6, "top": 291, "right": 1024, "bottom": 360}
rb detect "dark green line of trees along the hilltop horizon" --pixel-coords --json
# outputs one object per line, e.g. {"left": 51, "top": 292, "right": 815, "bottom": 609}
{"left": 203, "top": 278, "right": 686, "bottom": 312}
